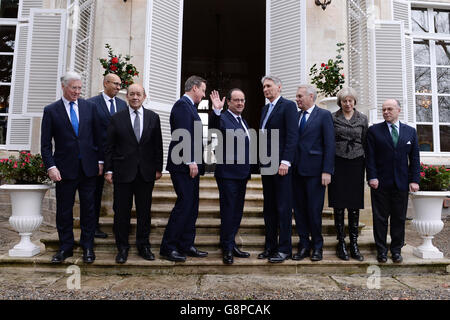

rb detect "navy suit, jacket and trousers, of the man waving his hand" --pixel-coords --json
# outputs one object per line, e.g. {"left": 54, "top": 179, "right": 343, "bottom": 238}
{"left": 209, "top": 111, "right": 250, "bottom": 252}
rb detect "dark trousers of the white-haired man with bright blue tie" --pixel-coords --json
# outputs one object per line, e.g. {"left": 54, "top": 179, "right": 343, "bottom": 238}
{"left": 56, "top": 163, "right": 96, "bottom": 251}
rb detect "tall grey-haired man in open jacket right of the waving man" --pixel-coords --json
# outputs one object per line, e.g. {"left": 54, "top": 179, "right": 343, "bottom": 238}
{"left": 258, "top": 76, "right": 298, "bottom": 263}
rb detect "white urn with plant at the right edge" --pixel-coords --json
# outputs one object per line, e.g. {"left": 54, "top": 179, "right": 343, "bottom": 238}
{"left": 411, "top": 163, "right": 450, "bottom": 259}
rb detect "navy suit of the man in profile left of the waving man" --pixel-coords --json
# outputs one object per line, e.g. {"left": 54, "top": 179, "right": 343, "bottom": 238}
{"left": 160, "top": 96, "right": 205, "bottom": 255}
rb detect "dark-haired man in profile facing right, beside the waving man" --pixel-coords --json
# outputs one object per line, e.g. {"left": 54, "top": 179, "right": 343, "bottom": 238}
{"left": 160, "top": 76, "right": 208, "bottom": 262}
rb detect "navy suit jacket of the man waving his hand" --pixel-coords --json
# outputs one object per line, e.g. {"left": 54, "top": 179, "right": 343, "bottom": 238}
{"left": 208, "top": 110, "right": 250, "bottom": 179}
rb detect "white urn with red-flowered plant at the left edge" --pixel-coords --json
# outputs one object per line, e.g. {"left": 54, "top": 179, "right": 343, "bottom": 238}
{"left": 0, "top": 151, "right": 50, "bottom": 257}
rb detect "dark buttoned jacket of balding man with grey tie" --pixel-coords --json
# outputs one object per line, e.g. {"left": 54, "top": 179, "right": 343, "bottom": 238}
{"left": 105, "top": 108, "right": 163, "bottom": 183}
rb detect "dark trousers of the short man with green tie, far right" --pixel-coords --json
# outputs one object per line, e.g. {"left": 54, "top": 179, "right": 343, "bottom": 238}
{"left": 370, "top": 188, "right": 408, "bottom": 253}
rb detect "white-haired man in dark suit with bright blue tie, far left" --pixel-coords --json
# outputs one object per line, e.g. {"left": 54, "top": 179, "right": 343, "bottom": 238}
{"left": 41, "top": 72, "right": 103, "bottom": 263}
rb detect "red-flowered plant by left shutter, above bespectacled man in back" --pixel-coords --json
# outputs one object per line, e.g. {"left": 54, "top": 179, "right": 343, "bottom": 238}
{"left": 99, "top": 44, "right": 139, "bottom": 98}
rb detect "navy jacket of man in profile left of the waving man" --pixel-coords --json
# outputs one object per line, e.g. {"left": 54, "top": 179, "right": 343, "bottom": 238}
{"left": 166, "top": 96, "right": 205, "bottom": 175}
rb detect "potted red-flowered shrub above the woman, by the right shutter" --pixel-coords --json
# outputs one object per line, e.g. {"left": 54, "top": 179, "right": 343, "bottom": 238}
{"left": 309, "top": 42, "right": 345, "bottom": 112}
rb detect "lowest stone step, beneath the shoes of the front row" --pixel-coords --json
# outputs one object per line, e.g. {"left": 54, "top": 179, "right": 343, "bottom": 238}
{"left": 0, "top": 246, "right": 450, "bottom": 276}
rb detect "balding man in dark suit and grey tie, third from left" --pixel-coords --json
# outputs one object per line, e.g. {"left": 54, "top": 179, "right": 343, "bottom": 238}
{"left": 105, "top": 84, "right": 163, "bottom": 263}
